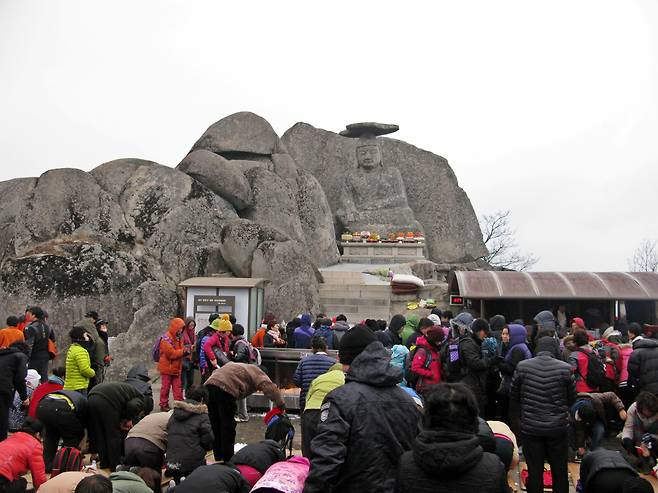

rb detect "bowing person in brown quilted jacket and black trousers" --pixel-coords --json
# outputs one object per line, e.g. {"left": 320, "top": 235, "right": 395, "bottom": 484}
{"left": 205, "top": 362, "right": 286, "bottom": 461}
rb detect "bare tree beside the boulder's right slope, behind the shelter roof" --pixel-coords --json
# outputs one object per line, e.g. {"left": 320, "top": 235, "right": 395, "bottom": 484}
{"left": 480, "top": 210, "right": 539, "bottom": 270}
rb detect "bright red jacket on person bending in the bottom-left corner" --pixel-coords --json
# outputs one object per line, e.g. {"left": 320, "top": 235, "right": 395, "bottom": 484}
{"left": 0, "top": 431, "right": 47, "bottom": 490}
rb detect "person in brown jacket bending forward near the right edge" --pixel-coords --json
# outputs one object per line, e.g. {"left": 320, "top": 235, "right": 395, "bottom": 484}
{"left": 569, "top": 392, "right": 627, "bottom": 457}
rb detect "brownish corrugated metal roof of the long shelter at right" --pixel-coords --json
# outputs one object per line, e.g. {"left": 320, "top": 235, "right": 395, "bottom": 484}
{"left": 449, "top": 271, "right": 658, "bottom": 300}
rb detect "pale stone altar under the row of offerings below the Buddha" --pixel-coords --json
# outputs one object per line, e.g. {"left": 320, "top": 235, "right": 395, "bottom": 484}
{"left": 340, "top": 241, "right": 425, "bottom": 264}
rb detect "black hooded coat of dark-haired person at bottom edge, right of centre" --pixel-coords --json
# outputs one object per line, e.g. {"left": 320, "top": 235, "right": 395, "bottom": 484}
{"left": 395, "top": 430, "right": 509, "bottom": 493}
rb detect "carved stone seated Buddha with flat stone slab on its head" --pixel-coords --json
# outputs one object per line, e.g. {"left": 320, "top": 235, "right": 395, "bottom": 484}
{"left": 337, "top": 123, "right": 423, "bottom": 236}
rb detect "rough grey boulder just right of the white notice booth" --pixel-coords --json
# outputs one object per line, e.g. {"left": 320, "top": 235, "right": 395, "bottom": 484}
{"left": 251, "top": 241, "right": 322, "bottom": 320}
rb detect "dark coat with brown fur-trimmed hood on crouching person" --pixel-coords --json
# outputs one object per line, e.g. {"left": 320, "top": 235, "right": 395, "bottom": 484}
{"left": 167, "top": 400, "right": 214, "bottom": 473}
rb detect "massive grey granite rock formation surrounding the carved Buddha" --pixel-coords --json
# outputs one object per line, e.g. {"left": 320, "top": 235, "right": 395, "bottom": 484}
{"left": 0, "top": 112, "right": 483, "bottom": 378}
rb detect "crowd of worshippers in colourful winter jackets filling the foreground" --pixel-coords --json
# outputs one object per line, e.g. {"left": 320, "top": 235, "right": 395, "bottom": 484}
{"left": 0, "top": 307, "right": 658, "bottom": 493}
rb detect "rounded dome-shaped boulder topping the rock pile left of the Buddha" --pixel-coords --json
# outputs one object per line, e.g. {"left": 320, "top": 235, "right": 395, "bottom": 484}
{"left": 192, "top": 111, "right": 279, "bottom": 155}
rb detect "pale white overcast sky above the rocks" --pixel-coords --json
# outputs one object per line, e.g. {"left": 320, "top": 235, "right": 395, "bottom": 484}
{"left": 0, "top": 0, "right": 658, "bottom": 270}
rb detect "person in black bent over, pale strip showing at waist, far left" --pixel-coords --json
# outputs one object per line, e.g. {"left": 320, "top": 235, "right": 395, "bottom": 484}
{"left": 36, "top": 390, "right": 87, "bottom": 473}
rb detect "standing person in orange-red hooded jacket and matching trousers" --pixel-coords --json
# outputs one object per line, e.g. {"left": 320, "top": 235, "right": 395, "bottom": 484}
{"left": 158, "top": 318, "right": 189, "bottom": 412}
